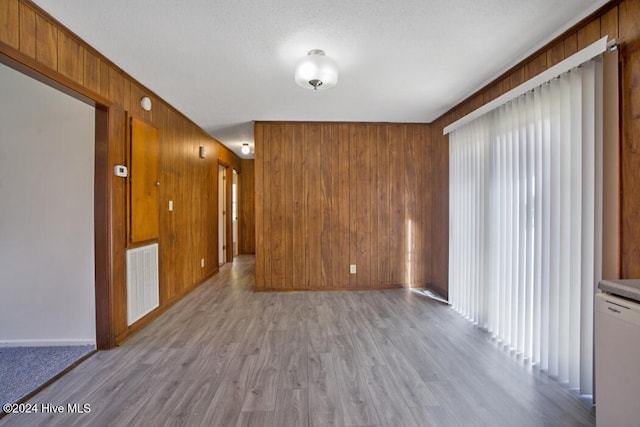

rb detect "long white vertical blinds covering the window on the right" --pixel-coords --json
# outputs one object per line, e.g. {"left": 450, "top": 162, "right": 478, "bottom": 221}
{"left": 449, "top": 58, "right": 602, "bottom": 394}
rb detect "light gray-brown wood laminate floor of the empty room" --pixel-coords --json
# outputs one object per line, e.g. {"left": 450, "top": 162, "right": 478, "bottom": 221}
{"left": 0, "top": 256, "right": 595, "bottom": 427}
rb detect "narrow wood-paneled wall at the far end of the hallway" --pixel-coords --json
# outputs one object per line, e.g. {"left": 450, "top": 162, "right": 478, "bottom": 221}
{"left": 238, "top": 159, "right": 256, "bottom": 254}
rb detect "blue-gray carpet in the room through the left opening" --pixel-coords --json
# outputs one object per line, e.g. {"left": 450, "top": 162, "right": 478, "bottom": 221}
{"left": 0, "top": 345, "right": 95, "bottom": 403}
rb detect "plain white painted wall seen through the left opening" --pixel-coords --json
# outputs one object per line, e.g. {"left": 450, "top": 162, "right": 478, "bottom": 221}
{"left": 0, "top": 64, "right": 96, "bottom": 346}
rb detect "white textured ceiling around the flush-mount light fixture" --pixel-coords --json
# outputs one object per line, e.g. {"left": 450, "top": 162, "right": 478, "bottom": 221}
{"left": 35, "top": 0, "right": 607, "bottom": 157}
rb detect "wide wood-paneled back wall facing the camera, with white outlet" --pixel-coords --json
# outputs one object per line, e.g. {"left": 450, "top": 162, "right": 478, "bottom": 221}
{"left": 255, "top": 122, "right": 448, "bottom": 291}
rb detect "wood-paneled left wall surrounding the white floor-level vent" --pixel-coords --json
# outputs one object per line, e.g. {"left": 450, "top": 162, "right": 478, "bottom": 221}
{"left": 0, "top": 0, "right": 241, "bottom": 348}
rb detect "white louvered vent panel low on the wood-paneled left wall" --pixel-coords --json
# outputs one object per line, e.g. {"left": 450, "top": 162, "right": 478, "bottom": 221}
{"left": 127, "top": 243, "right": 160, "bottom": 325}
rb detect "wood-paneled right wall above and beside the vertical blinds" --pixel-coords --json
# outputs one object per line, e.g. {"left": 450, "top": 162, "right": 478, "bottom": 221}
{"left": 433, "top": 0, "right": 640, "bottom": 279}
